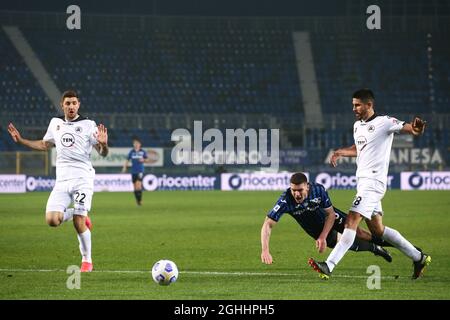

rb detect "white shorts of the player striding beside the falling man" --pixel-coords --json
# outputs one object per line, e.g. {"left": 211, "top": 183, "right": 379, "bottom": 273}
{"left": 350, "top": 178, "right": 386, "bottom": 220}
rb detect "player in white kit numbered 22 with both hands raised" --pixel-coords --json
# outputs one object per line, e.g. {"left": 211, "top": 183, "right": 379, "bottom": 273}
{"left": 8, "top": 91, "right": 108, "bottom": 272}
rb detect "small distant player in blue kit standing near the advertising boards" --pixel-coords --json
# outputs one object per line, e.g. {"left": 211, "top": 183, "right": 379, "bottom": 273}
{"left": 122, "top": 137, "right": 150, "bottom": 206}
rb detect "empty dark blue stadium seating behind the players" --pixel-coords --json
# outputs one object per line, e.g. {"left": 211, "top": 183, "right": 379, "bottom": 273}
{"left": 0, "top": 14, "right": 450, "bottom": 158}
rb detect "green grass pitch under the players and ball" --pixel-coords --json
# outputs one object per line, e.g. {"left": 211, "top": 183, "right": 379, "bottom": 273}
{"left": 0, "top": 190, "right": 450, "bottom": 300}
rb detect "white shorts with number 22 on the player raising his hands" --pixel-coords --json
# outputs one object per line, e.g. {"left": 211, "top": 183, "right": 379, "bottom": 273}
{"left": 46, "top": 178, "right": 94, "bottom": 216}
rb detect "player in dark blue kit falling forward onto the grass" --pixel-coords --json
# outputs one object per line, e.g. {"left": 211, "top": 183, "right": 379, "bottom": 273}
{"left": 261, "top": 172, "right": 392, "bottom": 264}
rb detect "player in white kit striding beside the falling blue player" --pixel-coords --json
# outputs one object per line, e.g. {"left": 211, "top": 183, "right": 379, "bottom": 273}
{"left": 308, "top": 89, "right": 431, "bottom": 279}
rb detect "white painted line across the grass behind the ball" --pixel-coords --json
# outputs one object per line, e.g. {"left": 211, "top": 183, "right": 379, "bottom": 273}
{"left": 0, "top": 269, "right": 404, "bottom": 279}
